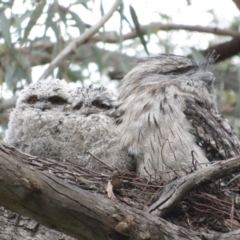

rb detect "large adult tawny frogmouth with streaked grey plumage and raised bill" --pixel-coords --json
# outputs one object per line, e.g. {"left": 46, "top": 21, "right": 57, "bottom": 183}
{"left": 118, "top": 55, "right": 240, "bottom": 177}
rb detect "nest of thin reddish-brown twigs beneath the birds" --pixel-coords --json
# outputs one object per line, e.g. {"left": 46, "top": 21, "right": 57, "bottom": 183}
{"left": 23, "top": 152, "right": 240, "bottom": 232}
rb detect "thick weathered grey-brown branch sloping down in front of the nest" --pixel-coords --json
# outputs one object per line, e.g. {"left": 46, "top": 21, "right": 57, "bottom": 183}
{"left": 0, "top": 144, "right": 240, "bottom": 239}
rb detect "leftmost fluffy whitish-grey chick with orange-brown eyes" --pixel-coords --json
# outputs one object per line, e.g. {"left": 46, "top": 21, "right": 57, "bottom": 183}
{"left": 4, "top": 79, "right": 71, "bottom": 159}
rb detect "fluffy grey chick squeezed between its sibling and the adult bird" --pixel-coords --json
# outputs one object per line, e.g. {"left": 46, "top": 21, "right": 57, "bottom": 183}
{"left": 63, "top": 85, "right": 134, "bottom": 171}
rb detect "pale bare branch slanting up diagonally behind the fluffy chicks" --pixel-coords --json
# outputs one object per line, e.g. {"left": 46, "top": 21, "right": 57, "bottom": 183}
{"left": 39, "top": 0, "right": 122, "bottom": 79}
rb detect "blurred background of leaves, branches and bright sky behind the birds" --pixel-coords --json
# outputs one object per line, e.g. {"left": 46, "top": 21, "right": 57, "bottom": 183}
{"left": 0, "top": 0, "right": 240, "bottom": 139}
